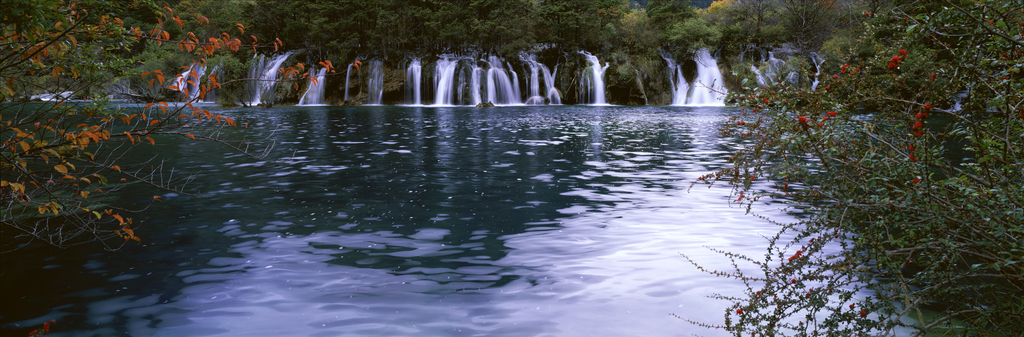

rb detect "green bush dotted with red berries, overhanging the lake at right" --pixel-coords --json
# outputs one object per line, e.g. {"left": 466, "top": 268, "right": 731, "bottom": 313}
{"left": 688, "top": 1, "right": 1024, "bottom": 336}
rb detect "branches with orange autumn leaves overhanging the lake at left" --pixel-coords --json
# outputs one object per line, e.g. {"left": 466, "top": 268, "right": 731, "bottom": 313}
{"left": 0, "top": 0, "right": 321, "bottom": 251}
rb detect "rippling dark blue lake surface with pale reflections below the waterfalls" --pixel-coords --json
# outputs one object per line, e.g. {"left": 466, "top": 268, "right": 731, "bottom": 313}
{"left": 0, "top": 107, "right": 784, "bottom": 336}
